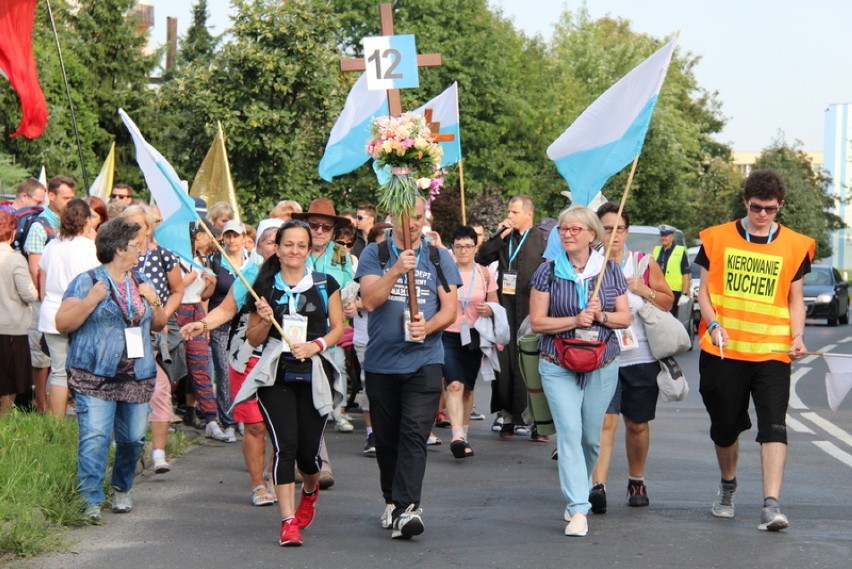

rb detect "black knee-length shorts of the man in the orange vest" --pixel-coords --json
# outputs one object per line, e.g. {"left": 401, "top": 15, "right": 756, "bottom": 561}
{"left": 698, "top": 351, "right": 790, "bottom": 448}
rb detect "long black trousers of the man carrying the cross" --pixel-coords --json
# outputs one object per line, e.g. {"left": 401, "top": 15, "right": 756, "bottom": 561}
{"left": 366, "top": 364, "right": 441, "bottom": 516}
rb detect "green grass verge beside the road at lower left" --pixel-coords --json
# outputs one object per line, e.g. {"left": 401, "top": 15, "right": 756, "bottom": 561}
{"left": 0, "top": 410, "right": 199, "bottom": 563}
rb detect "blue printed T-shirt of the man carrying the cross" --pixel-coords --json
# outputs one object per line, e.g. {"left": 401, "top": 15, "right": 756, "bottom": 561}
{"left": 355, "top": 243, "right": 462, "bottom": 374}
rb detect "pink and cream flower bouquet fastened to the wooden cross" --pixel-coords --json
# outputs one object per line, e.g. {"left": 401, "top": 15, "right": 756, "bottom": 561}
{"left": 366, "top": 113, "right": 444, "bottom": 216}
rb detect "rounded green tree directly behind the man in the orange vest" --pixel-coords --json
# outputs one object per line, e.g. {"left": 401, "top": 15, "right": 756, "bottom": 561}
{"left": 752, "top": 139, "right": 845, "bottom": 259}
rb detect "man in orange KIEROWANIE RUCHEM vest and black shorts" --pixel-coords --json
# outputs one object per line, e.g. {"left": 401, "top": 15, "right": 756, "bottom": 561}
{"left": 695, "top": 170, "right": 815, "bottom": 531}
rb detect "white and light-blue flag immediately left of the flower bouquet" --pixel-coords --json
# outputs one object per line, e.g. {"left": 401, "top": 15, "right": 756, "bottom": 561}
{"left": 319, "top": 73, "right": 389, "bottom": 182}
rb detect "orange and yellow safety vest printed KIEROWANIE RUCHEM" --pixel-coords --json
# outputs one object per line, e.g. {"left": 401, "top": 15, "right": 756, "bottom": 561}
{"left": 699, "top": 220, "right": 816, "bottom": 363}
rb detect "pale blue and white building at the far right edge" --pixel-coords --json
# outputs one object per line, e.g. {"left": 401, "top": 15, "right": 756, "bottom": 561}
{"left": 825, "top": 103, "right": 852, "bottom": 268}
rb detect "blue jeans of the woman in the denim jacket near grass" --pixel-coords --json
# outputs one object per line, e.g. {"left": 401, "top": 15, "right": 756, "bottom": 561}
{"left": 75, "top": 393, "right": 149, "bottom": 506}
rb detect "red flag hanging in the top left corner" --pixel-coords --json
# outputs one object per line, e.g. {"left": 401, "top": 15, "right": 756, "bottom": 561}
{"left": 0, "top": 0, "right": 47, "bottom": 138}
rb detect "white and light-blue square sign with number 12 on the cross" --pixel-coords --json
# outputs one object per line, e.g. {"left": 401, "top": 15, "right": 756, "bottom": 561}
{"left": 362, "top": 35, "right": 420, "bottom": 91}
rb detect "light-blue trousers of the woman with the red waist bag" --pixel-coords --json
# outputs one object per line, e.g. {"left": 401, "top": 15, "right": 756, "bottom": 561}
{"left": 538, "top": 358, "right": 618, "bottom": 516}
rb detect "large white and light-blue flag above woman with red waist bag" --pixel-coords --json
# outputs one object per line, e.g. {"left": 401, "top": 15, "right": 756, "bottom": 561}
{"left": 547, "top": 37, "right": 677, "bottom": 205}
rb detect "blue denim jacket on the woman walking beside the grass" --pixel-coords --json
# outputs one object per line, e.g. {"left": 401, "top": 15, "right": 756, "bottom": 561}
{"left": 62, "top": 265, "right": 157, "bottom": 380}
